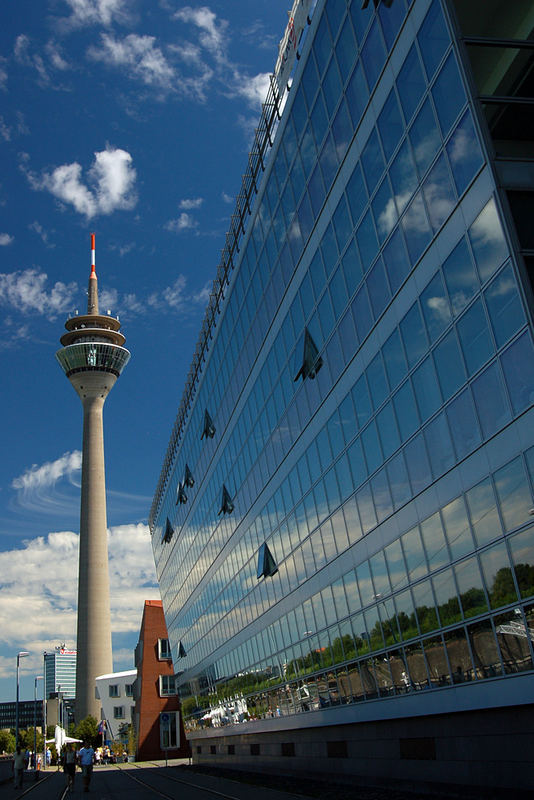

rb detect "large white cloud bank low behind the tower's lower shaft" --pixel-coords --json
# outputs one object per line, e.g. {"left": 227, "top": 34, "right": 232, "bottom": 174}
{"left": 0, "top": 524, "right": 159, "bottom": 677}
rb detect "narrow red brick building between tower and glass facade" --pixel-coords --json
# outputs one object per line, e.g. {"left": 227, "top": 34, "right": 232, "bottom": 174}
{"left": 134, "top": 600, "right": 190, "bottom": 761}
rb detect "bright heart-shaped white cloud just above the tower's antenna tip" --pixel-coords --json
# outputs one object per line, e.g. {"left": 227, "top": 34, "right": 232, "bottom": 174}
{"left": 21, "top": 146, "right": 137, "bottom": 219}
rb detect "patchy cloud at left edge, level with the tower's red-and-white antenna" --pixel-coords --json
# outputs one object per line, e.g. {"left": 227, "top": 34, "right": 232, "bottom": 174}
{"left": 0, "top": 269, "right": 78, "bottom": 317}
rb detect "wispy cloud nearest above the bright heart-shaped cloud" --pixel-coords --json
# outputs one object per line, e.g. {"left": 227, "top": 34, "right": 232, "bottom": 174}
{"left": 87, "top": 33, "right": 176, "bottom": 89}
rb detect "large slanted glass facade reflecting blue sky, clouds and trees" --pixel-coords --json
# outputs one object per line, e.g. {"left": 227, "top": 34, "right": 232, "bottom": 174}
{"left": 150, "top": 0, "right": 534, "bottom": 788}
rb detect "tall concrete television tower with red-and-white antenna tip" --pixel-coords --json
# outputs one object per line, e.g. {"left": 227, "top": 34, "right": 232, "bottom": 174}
{"left": 56, "top": 234, "right": 130, "bottom": 722}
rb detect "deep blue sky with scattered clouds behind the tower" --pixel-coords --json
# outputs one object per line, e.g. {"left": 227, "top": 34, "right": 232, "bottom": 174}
{"left": 0, "top": 0, "right": 291, "bottom": 701}
